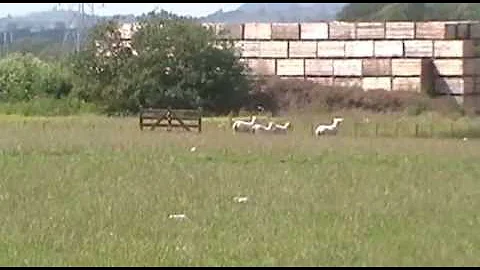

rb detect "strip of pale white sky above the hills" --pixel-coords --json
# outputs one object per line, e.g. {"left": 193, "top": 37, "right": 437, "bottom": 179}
{"left": 0, "top": 3, "right": 241, "bottom": 17}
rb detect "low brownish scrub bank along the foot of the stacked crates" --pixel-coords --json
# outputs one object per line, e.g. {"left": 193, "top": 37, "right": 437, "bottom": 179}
{"left": 245, "top": 77, "right": 459, "bottom": 115}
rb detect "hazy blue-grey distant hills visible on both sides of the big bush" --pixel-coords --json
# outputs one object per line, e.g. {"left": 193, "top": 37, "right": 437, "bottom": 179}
{"left": 0, "top": 3, "right": 346, "bottom": 57}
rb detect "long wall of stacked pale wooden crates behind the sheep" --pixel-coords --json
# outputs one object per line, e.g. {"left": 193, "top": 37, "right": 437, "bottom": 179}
{"left": 204, "top": 21, "right": 480, "bottom": 95}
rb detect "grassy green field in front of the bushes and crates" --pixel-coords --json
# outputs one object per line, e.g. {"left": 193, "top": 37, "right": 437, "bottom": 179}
{"left": 0, "top": 114, "right": 480, "bottom": 266}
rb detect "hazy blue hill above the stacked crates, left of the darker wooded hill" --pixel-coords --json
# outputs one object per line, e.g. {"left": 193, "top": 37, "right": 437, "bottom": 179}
{"left": 199, "top": 3, "right": 346, "bottom": 23}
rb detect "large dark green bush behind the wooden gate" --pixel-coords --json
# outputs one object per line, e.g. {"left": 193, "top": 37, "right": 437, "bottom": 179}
{"left": 73, "top": 13, "right": 250, "bottom": 113}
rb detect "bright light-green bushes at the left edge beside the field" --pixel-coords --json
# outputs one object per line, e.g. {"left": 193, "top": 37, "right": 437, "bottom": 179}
{"left": 0, "top": 53, "right": 95, "bottom": 116}
